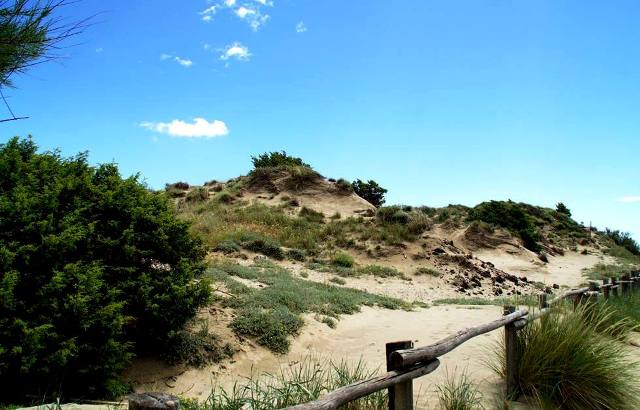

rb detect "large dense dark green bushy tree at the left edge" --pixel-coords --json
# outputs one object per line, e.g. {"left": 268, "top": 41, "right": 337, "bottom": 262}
{"left": 0, "top": 138, "right": 209, "bottom": 399}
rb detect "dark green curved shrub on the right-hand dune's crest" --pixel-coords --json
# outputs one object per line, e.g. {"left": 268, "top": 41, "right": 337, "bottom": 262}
{"left": 469, "top": 201, "right": 541, "bottom": 252}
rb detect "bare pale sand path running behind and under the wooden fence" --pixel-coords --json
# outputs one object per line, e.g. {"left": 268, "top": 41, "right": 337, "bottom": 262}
{"left": 129, "top": 306, "right": 510, "bottom": 408}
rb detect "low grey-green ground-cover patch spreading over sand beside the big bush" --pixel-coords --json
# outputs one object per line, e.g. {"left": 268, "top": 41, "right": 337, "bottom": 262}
{"left": 208, "top": 259, "right": 413, "bottom": 353}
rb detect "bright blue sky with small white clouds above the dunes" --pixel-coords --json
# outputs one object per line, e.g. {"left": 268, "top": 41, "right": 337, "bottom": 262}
{"left": 0, "top": 0, "right": 640, "bottom": 239}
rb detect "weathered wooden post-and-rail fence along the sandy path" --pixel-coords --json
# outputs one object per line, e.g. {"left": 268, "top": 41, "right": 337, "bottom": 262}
{"left": 129, "top": 272, "right": 640, "bottom": 410}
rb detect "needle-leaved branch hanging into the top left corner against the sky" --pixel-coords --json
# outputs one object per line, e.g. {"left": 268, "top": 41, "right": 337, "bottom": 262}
{"left": 0, "top": 0, "right": 86, "bottom": 121}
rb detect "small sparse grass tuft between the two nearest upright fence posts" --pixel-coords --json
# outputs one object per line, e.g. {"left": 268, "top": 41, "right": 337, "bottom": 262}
{"left": 437, "top": 371, "right": 484, "bottom": 410}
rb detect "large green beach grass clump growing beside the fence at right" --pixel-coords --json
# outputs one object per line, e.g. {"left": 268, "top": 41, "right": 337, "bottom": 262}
{"left": 494, "top": 306, "right": 640, "bottom": 410}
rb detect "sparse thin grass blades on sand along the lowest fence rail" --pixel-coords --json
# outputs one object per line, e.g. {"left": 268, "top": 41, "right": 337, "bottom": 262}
{"left": 180, "top": 356, "right": 387, "bottom": 410}
